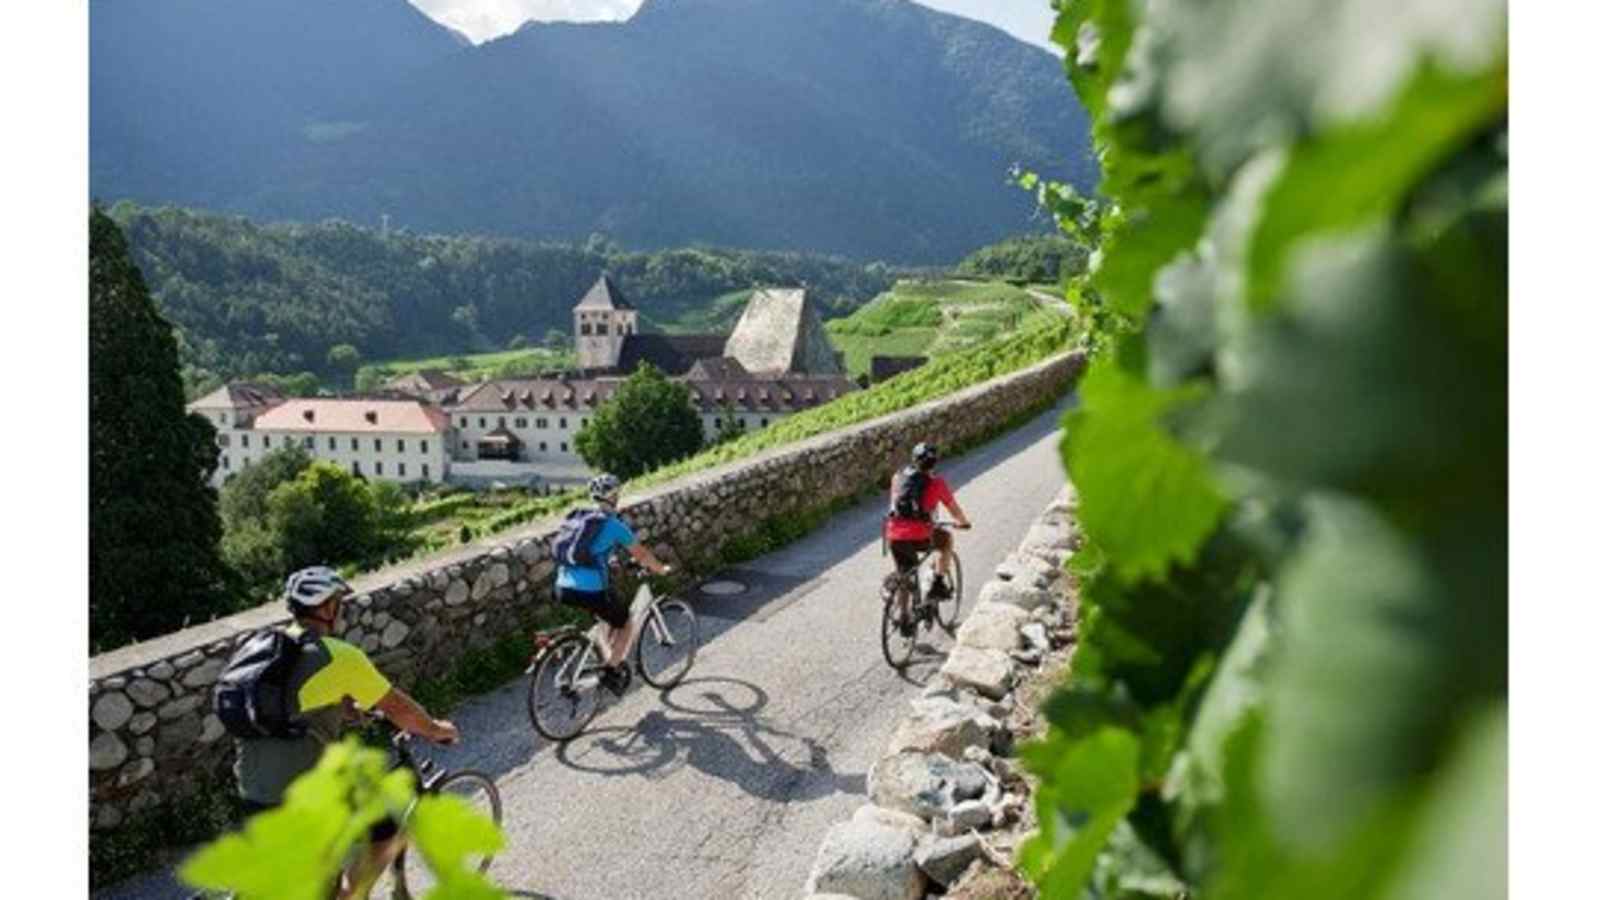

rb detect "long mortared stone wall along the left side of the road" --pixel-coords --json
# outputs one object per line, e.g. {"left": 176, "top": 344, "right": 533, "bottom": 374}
{"left": 90, "top": 354, "right": 1083, "bottom": 831}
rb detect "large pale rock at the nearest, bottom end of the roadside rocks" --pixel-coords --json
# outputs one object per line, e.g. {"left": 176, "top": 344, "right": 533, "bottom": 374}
{"left": 805, "top": 820, "right": 926, "bottom": 900}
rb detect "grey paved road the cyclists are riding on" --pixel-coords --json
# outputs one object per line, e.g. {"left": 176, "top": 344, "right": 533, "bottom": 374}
{"left": 99, "top": 400, "right": 1064, "bottom": 900}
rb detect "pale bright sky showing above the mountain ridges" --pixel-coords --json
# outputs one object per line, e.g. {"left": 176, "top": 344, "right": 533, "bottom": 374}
{"left": 411, "top": 0, "right": 1054, "bottom": 50}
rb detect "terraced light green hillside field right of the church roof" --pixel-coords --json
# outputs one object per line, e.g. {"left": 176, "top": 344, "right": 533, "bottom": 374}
{"left": 827, "top": 279, "right": 1040, "bottom": 376}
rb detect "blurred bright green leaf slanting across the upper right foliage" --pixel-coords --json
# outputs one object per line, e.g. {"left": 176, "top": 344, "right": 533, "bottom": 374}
{"left": 1250, "top": 61, "right": 1506, "bottom": 309}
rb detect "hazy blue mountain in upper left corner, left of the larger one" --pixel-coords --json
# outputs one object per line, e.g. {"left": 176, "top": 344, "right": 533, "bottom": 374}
{"left": 90, "top": 0, "right": 462, "bottom": 213}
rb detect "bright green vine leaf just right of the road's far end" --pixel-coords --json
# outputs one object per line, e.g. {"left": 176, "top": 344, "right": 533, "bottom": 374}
{"left": 1062, "top": 347, "right": 1227, "bottom": 580}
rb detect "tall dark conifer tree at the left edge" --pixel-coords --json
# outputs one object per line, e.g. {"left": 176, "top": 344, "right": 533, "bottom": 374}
{"left": 90, "top": 207, "right": 234, "bottom": 649}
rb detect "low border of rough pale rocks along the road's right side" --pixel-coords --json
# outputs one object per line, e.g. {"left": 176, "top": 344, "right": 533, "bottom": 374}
{"left": 805, "top": 485, "right": 1077, "bottom": 900}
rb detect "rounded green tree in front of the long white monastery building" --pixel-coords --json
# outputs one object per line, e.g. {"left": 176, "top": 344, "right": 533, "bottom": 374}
{"left": 578, "top": 362, "right": 706, "bottom": 479}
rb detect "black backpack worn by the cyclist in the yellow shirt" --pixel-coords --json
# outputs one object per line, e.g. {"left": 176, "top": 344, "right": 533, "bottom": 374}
{"left": 211, "top": 628, "right": 315, "bottom": 738}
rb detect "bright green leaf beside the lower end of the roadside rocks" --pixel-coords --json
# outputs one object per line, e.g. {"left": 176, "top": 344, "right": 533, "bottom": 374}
{"left": 1019, "top": 729, "right": 1139, "bottom": 900}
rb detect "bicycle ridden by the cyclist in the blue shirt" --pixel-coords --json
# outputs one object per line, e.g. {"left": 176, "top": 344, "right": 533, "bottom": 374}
{"left": 528, "top": 560, "right": 699, "bottom": 741}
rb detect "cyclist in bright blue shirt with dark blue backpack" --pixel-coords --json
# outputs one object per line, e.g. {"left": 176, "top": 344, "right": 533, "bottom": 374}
{"left": 555, "top": 474, "right": 672, "bottom": 695}
